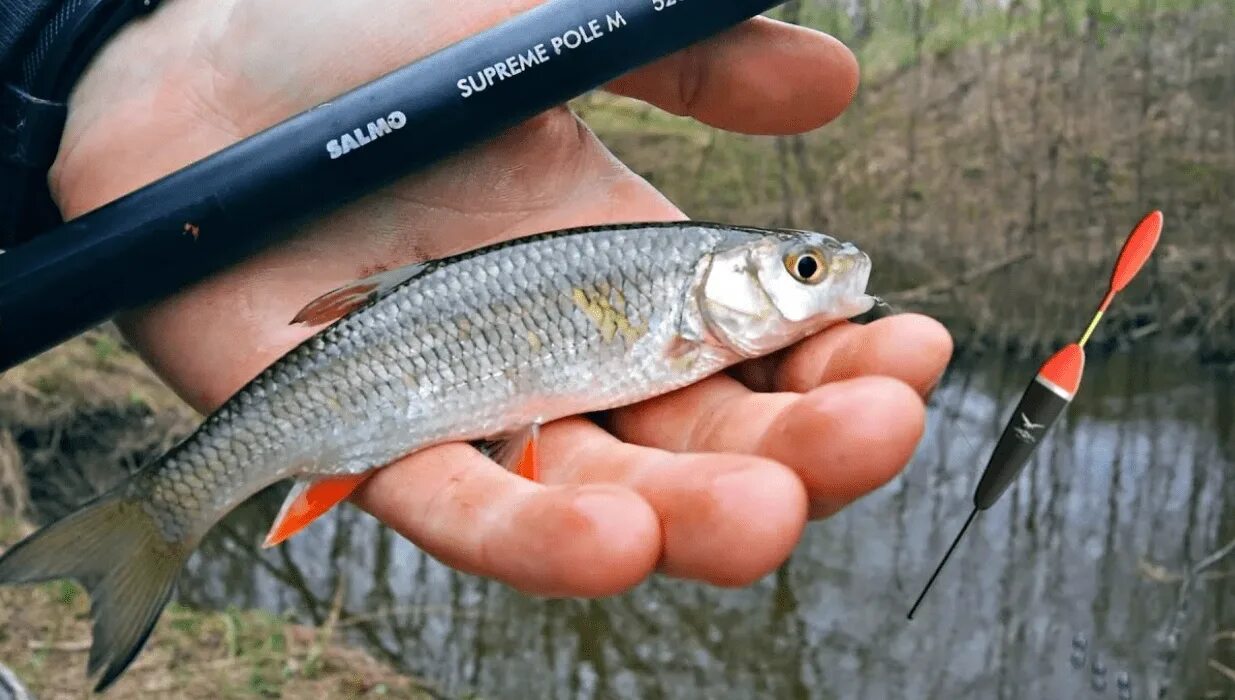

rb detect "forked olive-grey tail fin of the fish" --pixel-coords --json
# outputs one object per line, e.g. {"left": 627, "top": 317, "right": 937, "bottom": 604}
{"left": 0, "top": 489, "right": 191, "bottom": 693}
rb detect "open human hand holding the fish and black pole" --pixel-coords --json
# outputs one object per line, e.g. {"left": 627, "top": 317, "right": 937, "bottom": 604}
{"left": 52, "top": 0, "right": 951, "bottom": 596}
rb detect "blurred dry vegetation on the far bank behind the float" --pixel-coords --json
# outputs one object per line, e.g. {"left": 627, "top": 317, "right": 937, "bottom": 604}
{"left": 577, "top": 0, "right": 1235, "bottom": 362}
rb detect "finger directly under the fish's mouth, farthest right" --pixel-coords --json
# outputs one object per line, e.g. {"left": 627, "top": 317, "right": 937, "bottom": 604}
{"left": 772, "top": 314, "right": 952, "bottom": 398}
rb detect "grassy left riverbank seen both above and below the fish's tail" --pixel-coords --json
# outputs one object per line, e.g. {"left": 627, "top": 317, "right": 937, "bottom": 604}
{"left": 0, "top": 335, "right": 431, "bottom": 700}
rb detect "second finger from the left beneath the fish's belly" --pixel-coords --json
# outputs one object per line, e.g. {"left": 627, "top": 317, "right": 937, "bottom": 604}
{"left": 541, "top": 419, "right": 806, "bottom": 585}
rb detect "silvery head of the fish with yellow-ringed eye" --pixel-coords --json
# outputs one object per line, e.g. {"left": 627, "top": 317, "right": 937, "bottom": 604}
{"left": 700, "top": 231, "right": 874, "bottom": 357}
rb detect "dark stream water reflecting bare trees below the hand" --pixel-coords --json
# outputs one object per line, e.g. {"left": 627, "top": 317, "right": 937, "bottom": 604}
{"left": 174, "top": 348, "right": 1235, "bottom": 700}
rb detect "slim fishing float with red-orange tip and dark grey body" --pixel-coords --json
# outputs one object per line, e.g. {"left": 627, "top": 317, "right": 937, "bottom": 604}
{"left": 909, "top": 211, "right": 1162, "bottom": 620}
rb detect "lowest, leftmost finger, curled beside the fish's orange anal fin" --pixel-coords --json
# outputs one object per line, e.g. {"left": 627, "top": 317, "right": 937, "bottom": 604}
{"left": 353, "top": 443, "right": 661, "bottom": 598}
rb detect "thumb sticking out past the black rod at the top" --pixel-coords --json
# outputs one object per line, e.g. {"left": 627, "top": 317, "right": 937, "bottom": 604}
{"left": 608, "top": 17, "right": 858, "bottom": 133}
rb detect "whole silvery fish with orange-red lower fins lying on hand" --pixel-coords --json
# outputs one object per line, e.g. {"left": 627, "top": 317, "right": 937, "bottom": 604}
{"left": 0, "top": 221, "right": 874, "bottom": 691}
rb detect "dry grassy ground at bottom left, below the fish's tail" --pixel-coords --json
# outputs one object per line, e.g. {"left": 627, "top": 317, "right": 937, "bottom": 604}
{"left": 0, "top": 519, "right": 431, "bottom": 700}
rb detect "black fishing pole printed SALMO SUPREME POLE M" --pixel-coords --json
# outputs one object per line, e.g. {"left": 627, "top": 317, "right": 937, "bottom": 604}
{"left": 0, "top": 0, "right": 784, "bottom": 372}
